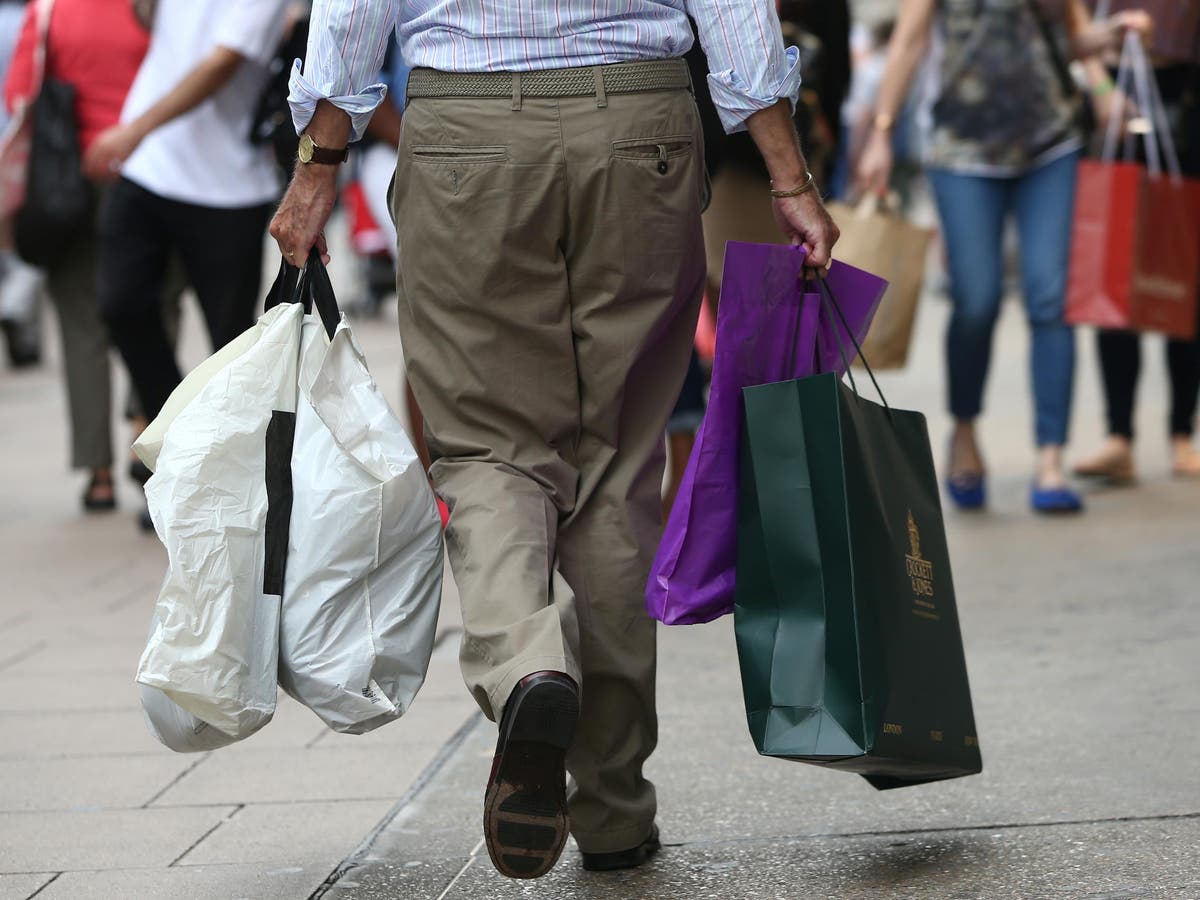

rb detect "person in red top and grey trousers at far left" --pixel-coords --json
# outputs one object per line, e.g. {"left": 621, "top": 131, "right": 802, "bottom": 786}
{"left": 5, "top": 0, "right": 149, "bottom": 510}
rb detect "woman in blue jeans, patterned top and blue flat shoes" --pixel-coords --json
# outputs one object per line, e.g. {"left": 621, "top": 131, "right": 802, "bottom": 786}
{"left": 858, "top": 0, "right": 1148, "bottom": 512}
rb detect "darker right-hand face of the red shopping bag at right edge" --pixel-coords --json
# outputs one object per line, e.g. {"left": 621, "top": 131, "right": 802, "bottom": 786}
{"left": 1130, "top": 175, "right": 1200, "bottom": 340}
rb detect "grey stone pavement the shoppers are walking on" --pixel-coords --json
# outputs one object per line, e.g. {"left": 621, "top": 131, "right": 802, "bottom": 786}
{"left": 0, "top": 236, "right": 1200, "bottom": 900}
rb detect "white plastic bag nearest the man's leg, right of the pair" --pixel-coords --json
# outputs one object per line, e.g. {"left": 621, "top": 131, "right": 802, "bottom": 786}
{"left": 280, "top": 319, "right": 443, "bottom": 734}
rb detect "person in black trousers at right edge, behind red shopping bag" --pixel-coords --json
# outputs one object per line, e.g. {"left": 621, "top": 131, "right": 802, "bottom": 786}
{"left": 1075, "top": 0, "right": 1200, "bottom": 484}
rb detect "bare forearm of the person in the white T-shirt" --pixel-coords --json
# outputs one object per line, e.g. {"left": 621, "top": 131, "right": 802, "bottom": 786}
{"left": 83, "top": 47, "right": 244, "bottom": 179}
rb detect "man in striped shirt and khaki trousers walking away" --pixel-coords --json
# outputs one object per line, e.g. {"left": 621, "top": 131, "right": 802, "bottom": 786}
{"left": 271, "top": 0, "right": 838, "bottom": 877}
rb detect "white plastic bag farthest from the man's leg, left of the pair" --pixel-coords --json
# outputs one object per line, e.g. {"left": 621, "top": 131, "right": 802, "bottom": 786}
{"left": 134, "top": 304, "right": 304, "bottom": 739}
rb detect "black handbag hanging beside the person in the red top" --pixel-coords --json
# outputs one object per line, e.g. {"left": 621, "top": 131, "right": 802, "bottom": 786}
{"left": 13, "top": 14, "right": 95, "bottom": 268}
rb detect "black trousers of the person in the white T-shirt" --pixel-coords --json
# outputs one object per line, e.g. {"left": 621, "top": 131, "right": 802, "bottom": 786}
{"left": 97, "top": 179, "right": 274, "bottom": 419}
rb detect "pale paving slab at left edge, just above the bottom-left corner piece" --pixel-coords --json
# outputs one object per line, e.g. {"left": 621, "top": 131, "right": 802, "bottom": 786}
{"left": 0, "top": 805, "right": 236, "bottom": 872}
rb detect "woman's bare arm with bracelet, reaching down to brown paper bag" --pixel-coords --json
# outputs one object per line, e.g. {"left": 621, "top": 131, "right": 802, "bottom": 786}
{"left": 857, "top": 0, "right": 935, "bottom": 193}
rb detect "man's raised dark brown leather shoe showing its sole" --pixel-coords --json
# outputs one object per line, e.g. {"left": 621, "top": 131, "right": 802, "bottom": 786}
{"left": 484, "top": 672, "right": 580, "bottom": 878}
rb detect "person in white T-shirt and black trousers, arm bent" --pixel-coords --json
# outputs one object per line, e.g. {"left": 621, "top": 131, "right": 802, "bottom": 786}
{"left": 84, "top": 0, "right": 288, "bottom": 420}
